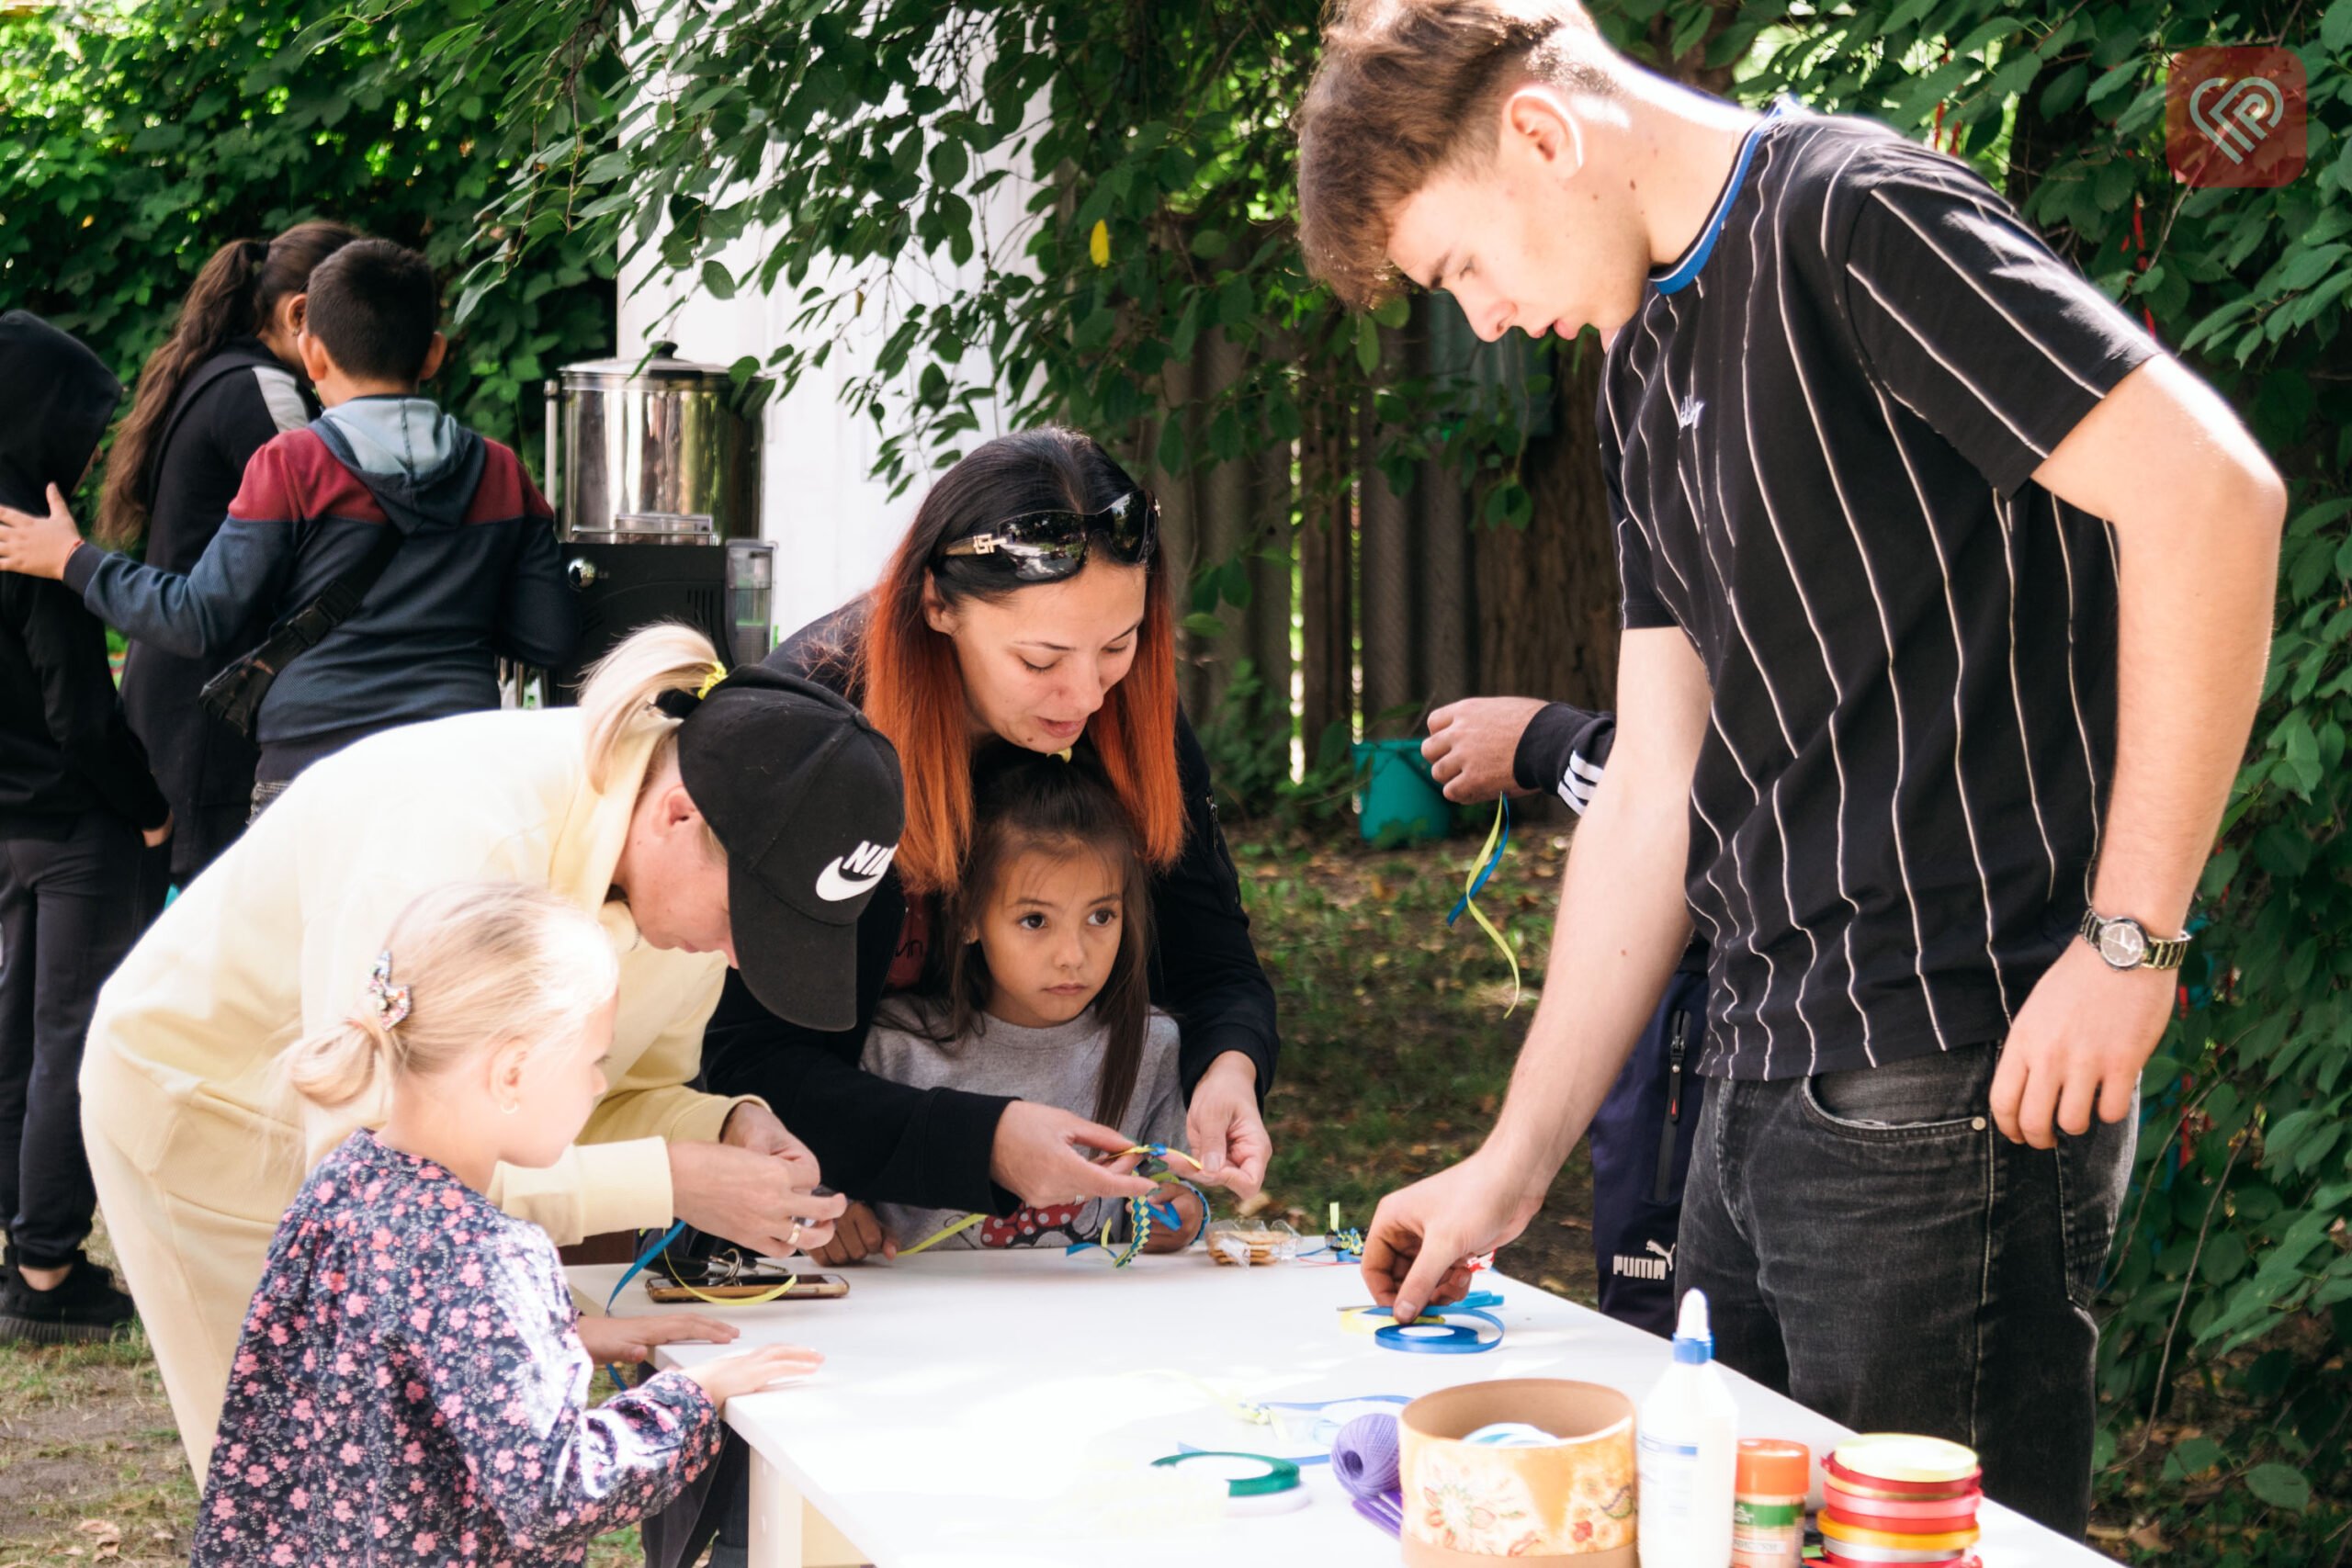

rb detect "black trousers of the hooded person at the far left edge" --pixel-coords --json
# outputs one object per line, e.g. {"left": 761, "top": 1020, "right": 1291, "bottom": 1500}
{"left": 0, "top": 811, "right": 167, "bottom": 1269}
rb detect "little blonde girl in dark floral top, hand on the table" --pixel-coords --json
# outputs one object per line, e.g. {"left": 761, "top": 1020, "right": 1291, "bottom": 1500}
{"left": 193, "top": 884, "right": 820, "bottom": 1568}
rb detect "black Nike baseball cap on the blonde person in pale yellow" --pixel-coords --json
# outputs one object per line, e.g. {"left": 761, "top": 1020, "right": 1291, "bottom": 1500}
{"left": 677, "top": 665, "right": 906, "bottom": 1032}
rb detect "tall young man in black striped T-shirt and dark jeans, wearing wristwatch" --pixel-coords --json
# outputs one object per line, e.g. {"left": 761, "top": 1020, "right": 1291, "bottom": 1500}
{"left": 1298, "top": 0, "right": 2284, "bottom": 1530}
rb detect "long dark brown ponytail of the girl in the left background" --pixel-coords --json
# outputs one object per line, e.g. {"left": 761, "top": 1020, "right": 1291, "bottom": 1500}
{"left": 92, "top": 221, "right": 360, "bottom": 547}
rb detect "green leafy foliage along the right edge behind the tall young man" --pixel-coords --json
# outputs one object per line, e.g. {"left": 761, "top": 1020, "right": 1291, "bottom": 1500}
{"left": 1749, "top": 0, "right": 2352, "bottom": 1561}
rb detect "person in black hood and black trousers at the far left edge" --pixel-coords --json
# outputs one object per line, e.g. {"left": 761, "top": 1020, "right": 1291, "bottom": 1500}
{"left": 0, "top": 310, "right": 172, "bottom": 1342}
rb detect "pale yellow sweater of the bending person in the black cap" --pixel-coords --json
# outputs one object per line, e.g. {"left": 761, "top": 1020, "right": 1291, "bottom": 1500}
{"left": 83, "top": 710, "right": 736, "bottom": 1241}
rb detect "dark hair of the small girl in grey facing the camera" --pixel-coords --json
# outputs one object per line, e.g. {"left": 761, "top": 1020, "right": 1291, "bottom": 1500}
{"left": 936, "top": 745, "right": 1152, "bottom": 1126}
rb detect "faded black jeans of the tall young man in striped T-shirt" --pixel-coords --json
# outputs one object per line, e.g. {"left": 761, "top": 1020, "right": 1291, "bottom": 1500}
{"left": 1677, "top": 1046, "right": 2138, "bottom": 1538}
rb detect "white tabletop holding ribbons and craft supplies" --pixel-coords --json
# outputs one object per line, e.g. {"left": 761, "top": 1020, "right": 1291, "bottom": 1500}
{"left": 571, "top": 1251, "right": 2108, "bottom": 1568}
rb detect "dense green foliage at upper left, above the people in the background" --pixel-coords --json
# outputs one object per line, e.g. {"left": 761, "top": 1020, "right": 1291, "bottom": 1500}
{"left": 0, "top": 0, "right": 612, "bottom": 472}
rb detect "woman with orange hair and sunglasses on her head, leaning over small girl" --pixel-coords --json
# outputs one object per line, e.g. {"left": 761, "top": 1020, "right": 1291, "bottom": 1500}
{"left": 703, "top": 428, "right": 1277, "bottom": 1222}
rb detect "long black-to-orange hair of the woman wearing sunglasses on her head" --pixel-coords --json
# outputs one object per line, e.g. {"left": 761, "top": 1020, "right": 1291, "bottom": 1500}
{"left": 854, "top": 425, "right": 1185, "bottom": 894}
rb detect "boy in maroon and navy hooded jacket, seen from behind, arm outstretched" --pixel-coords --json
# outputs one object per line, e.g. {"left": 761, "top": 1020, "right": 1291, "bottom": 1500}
{"left": 0, "top": 240, "right": 579, "bottom": 811}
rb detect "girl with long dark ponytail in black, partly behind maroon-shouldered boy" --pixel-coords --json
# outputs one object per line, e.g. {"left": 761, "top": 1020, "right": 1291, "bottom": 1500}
{"left": 89, "top": 221, "right": 360, "bottom": 886}
